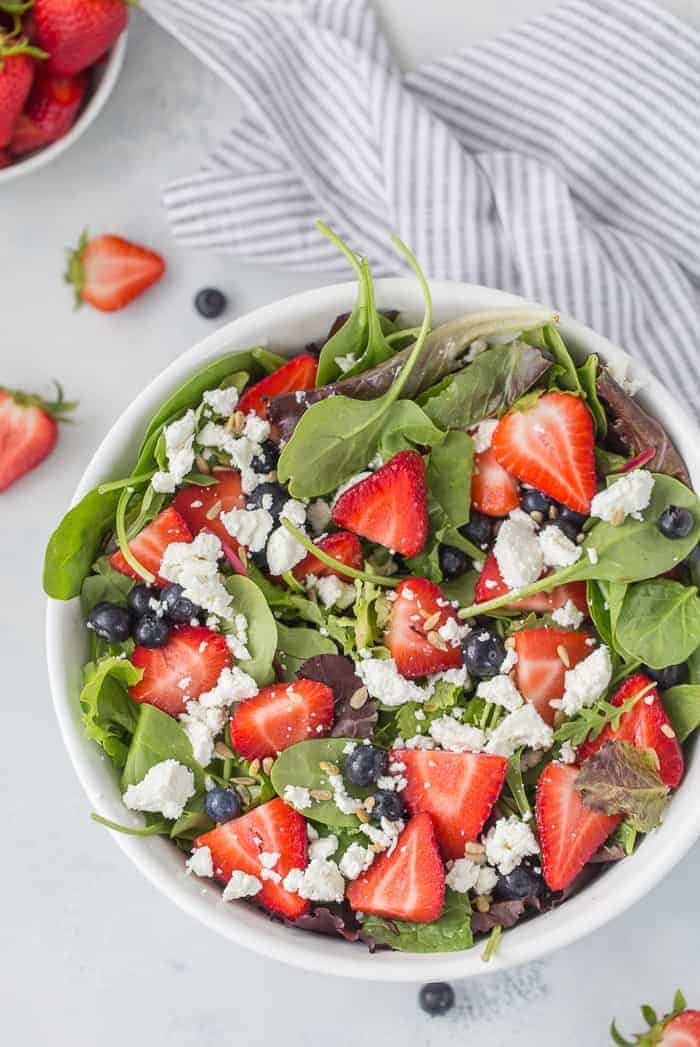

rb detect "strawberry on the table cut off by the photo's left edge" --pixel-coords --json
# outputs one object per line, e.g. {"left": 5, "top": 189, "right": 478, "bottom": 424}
{"left": 0, "top": 383, "right": 75, "bottom": 491}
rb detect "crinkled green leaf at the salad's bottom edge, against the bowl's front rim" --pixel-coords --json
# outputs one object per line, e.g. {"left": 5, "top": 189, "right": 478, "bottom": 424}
{"left": 361, "top": 889, "right": 474, "bottom": 953}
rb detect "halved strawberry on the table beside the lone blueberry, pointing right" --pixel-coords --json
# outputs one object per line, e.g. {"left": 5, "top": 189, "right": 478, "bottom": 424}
{"left": 64, "top": 231, "right": 165, "bottom": 313}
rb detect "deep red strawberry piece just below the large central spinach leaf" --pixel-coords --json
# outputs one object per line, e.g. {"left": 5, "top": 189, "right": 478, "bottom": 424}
{"left": 333, "top": 451, "right": 428, "bottom": 556}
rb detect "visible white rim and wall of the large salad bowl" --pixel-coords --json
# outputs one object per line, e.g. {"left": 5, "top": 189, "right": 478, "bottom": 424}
{"left": 46, "top": 279, "right": 700, "bottom": 982}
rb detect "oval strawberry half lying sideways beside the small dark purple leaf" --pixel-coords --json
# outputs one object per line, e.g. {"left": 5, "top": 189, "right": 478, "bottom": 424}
{"left": 230, "top": 680, "right": 334, "bottom": 760}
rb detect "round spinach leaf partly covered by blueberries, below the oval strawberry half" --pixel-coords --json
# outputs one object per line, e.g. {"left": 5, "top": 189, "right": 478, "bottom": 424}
{"left": 270, "top": 738, "right": 372, "bottom": 828}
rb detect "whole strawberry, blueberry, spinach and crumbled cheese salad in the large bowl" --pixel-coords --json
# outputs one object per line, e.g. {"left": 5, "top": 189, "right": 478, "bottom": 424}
{"left": 44, "top": 227, "right": 700, "bottom": 956}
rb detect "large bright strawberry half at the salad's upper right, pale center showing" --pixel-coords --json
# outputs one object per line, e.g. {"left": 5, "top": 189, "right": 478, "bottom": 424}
{"left": 491, "top": 392, "right": 595, "bottom": 513}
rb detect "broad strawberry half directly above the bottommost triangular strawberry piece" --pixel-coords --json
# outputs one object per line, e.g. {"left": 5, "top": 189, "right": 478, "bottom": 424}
{"left": 391, "top": 749, "right": 507, "bottom": 859}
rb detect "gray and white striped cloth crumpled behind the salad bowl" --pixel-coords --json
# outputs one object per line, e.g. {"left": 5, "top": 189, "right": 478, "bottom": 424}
{"left": 143, "top": 0, "right": 700, "bottom": 399}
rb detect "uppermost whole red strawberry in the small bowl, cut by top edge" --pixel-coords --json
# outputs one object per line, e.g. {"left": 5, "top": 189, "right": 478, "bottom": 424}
{"left": 33, "top": 0, "right": 131, "bottom": 76}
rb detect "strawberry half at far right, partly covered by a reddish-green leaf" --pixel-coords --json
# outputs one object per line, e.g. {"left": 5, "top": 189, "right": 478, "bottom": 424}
{"left": 579, "top": 672, "right": 684, "bottom": 788}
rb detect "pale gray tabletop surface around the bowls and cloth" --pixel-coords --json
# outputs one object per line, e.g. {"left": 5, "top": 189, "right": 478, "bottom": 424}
{"left": 0, "top": 0, "right": 700, "bottom": 1047}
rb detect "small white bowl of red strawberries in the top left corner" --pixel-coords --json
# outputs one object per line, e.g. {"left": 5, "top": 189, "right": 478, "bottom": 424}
{"left": 0, "top": 0, "right": 129, "bottom": 185}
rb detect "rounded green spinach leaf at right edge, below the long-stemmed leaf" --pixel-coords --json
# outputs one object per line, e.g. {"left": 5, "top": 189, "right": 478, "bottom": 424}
{"left": 615, "top": 578, "right": 700, "bottom": 669}
